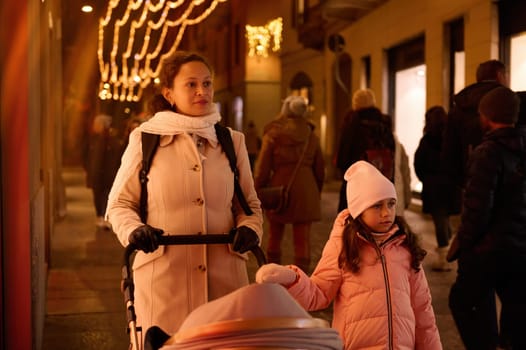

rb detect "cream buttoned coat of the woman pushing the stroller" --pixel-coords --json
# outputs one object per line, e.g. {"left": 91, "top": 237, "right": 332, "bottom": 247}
{"left": 107, "top": 124, "right": 263, "bottom": 334}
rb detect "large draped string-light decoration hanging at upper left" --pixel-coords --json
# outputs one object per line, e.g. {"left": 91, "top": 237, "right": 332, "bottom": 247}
{"left": 97, "top": 0, "right": 227, "bottom": 101}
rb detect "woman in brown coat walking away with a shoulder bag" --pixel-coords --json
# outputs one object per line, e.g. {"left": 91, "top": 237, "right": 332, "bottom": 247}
{"left": 254, "top": 96, "right": 325, "bottom": 271}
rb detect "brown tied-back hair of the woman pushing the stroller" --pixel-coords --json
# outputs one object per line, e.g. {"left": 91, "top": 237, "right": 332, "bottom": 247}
{"left": 149, "top": 51, "right": 214, "bottom": 114}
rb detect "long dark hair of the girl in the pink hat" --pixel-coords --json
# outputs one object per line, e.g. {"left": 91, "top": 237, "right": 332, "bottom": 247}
{"left": 338, "top": 216, "right": 427, "bottom": 273}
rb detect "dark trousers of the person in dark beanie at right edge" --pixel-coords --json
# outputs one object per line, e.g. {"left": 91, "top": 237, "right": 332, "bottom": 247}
{"left": 449, "top": 252, "right": 526, "bottom": 350}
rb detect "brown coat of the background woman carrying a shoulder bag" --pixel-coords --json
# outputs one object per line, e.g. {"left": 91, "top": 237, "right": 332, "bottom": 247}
{"left": 254, "top": 115, "right": 325, "bottom": 224}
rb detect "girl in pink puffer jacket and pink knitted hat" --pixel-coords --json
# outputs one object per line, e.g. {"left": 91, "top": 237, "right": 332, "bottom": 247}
{"left": 256, "top": 161, "right": 442, "bottom": 350}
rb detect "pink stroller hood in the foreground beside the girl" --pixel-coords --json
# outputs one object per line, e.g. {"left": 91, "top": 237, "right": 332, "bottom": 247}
{"left": 161, "top": 283, "right": 343, "bottom": 350}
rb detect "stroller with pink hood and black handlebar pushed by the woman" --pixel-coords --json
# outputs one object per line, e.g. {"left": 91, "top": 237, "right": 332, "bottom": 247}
{"left": 121, "top": 229, "right": 343, "bottom": 350}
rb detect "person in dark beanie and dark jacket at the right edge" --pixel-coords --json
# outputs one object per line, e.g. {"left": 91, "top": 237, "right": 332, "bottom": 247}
{"left": 449, "top": 86, "right": 526, "bottom": 350}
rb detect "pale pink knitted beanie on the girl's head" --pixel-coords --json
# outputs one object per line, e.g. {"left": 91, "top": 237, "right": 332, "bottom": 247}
{"left": 344, "top": 160, "right": 396, "bottom": 219}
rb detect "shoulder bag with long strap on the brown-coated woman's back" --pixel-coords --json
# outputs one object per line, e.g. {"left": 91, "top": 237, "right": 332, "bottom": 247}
{"left": 257, "top": 129, "right": 310, "bottom": 213}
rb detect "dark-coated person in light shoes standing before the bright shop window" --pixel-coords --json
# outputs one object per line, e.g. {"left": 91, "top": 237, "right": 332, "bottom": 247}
{"left": 414, "top": 106, "right": 458, "bottom": 271}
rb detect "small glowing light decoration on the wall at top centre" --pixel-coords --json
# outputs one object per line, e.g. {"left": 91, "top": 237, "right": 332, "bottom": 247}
{"left": 245, "top": 17, "right": 283, "bottom": 57}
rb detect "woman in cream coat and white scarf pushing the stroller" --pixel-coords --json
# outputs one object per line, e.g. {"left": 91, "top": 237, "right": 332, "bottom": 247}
{"left": 106, "top": 52, "right": 263, "bottom": 342}
